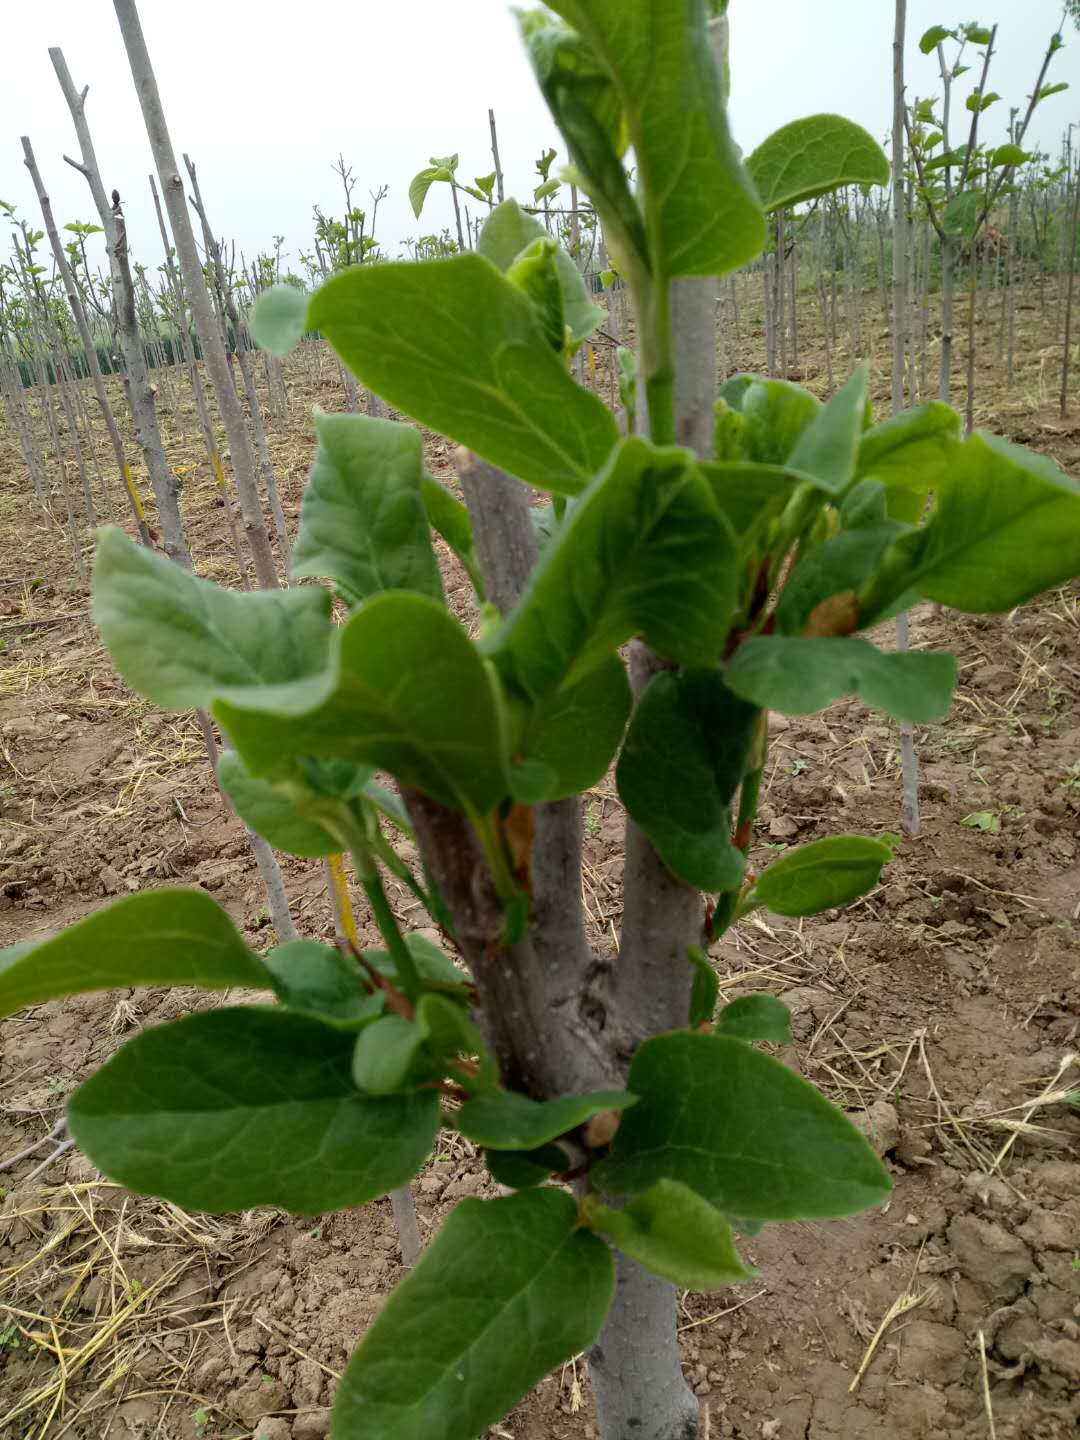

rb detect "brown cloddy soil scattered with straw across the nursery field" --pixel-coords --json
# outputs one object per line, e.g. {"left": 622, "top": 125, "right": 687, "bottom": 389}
{"left": 0, "top": 289, "right": 1080, "bottom": 1440}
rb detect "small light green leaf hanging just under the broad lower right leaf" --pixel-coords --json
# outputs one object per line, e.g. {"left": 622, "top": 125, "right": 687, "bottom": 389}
{"left": 589, "top": 1179, "right": 756, "bottom": 1290}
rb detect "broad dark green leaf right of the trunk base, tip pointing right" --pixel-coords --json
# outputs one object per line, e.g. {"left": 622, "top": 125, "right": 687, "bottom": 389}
{"left": 593, "top": 1031, "right": 890, "bottom": 1220}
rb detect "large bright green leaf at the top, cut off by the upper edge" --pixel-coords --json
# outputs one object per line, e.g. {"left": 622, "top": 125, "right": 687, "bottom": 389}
{"left": 550, "top": 0, "right": 765, "bottom": 275}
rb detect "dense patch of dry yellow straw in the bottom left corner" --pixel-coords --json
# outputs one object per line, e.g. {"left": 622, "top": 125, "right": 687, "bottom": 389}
{"left": 0, "top": 1179, "right": 288, "bottom": 1440}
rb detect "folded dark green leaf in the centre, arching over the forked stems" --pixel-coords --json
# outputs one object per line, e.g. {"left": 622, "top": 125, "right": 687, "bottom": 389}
{"left": 488, "top": 439, "right": 737, "bottom": 700}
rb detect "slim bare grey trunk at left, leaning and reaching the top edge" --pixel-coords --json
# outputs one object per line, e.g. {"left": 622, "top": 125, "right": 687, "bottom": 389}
{"left": 112, "top": 0, "right": 278, "bottom": 589}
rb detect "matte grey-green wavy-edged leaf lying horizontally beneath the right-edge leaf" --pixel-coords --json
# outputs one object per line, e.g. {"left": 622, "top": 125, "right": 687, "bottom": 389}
{"left": 724, "top": 635, "right": 956, "bottom": 724}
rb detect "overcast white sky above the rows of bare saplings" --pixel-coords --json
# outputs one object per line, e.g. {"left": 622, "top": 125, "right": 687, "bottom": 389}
{"left": 0, "top": 0, "right": 1080, "bottom": 283}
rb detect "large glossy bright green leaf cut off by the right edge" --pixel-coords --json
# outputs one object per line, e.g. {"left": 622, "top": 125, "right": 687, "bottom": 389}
{"left": 865, "top": 431, "right": 1080, "bottom": 615}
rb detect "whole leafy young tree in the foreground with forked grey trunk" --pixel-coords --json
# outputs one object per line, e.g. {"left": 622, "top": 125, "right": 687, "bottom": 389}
{"left": 0, "top": 0, "right": 1080, "bottom": 1440}
